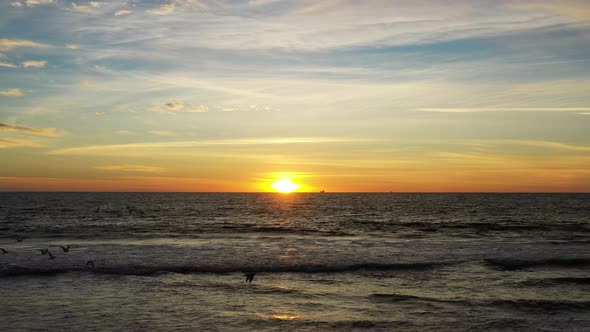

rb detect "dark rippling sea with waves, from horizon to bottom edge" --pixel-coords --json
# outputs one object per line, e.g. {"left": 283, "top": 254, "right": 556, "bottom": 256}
{"left": 0, "top": 193, "right": 590, "bottom": 331}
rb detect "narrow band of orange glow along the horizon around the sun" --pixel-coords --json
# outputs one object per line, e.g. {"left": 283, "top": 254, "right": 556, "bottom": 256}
{"left": 0, "top": 169, "right": 590, "bottom": 196}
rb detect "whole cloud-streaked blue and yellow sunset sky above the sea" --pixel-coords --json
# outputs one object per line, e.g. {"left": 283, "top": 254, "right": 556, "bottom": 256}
{"left": 0, "top": 0, "right": 590, "bottom": 192}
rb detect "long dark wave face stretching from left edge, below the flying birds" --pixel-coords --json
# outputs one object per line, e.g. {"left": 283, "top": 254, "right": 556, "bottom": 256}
{"left": 0, "top": 262, "right": 446, "bottom": 277}
